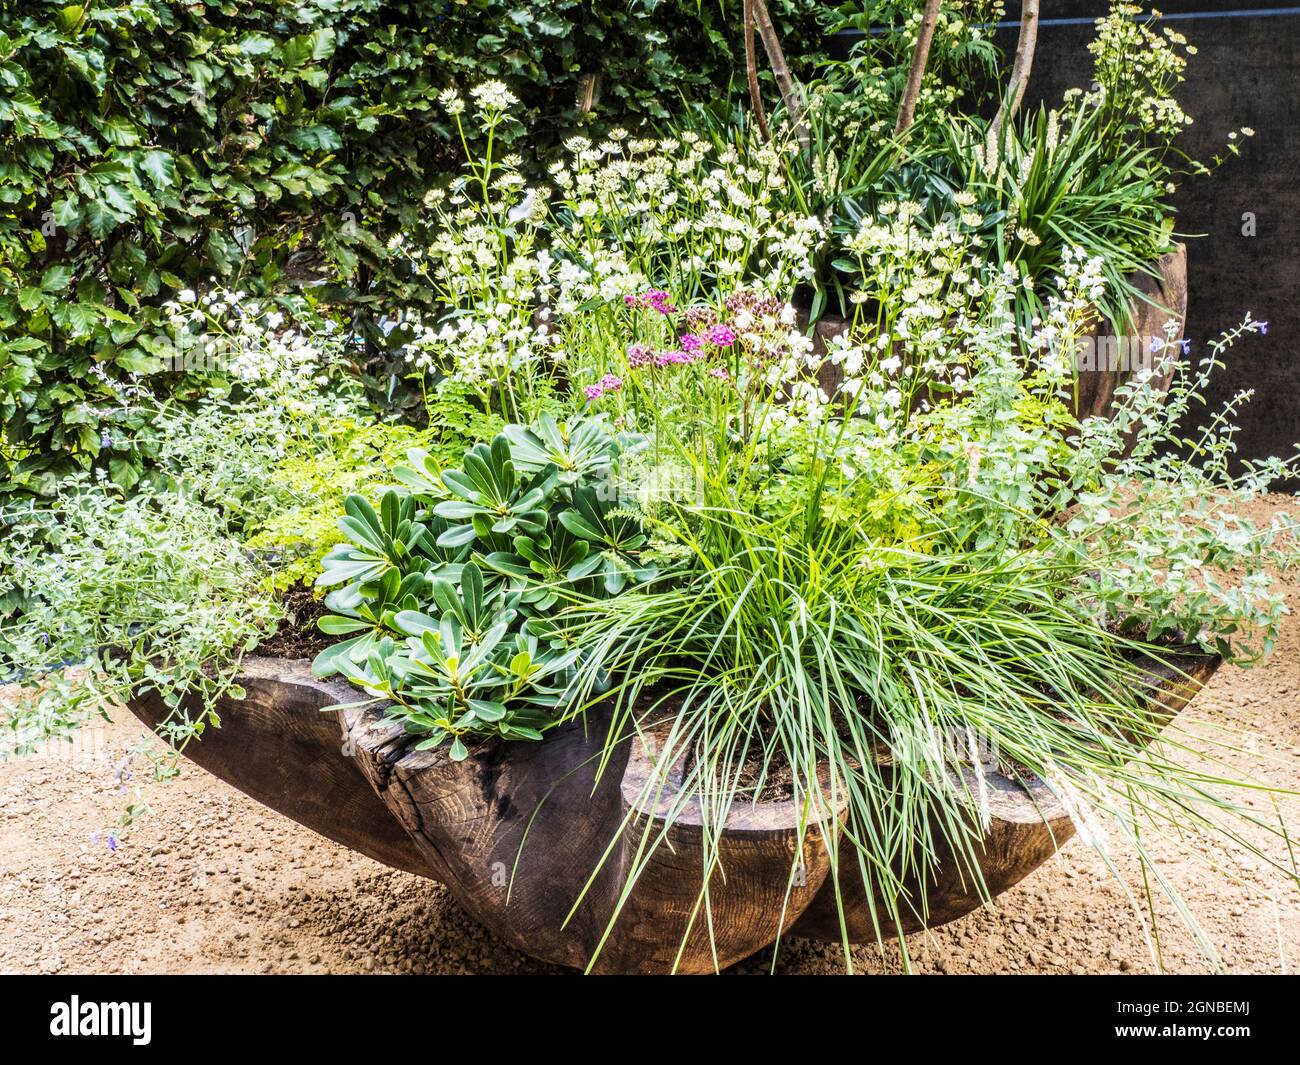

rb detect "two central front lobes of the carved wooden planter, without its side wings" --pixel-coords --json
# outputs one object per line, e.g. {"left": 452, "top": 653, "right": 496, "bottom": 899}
{"left": 330, "top": 709, "right": 847, "bottom": 973}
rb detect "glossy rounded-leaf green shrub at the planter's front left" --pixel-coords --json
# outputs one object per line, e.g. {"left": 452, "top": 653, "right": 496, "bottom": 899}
{"left": 312, "top": 415, "right": 657, "bottom": 761}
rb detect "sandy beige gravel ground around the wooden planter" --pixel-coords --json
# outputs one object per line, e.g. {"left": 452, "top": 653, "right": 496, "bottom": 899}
{"left": 0, "top": 506, "right": 1300, "bottom": 973}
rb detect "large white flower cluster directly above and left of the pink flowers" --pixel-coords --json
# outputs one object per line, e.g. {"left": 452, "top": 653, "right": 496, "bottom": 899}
{"left": 393, "top": 94, "right": 826, "bottom": 413}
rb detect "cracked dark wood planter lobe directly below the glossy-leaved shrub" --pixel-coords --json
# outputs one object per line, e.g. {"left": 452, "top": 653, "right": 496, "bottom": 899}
{"left": 341, "top": 709, "right": 637, "bottom": 967}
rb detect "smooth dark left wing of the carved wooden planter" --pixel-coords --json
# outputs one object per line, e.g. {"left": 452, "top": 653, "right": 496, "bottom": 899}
{"left": 127, "top": 657, "right": 428, "bottom": 875}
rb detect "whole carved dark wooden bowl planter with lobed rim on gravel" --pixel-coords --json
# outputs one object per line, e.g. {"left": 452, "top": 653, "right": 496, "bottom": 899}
{"left": 130, "top": 644, "right": 1218, "bottom": 973}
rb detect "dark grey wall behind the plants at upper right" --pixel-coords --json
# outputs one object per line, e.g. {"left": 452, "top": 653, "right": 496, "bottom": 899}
{"left": 1001, "top": 0, "right": 1300, "bottom": 475}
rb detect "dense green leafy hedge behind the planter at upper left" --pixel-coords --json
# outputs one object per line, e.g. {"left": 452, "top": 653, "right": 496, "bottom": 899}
{"left": 0, "top": 0, "right": 816, "bottom": 499}
